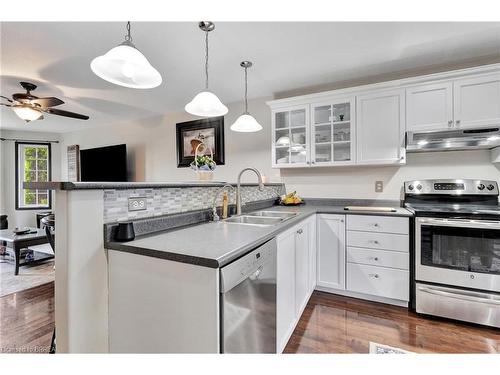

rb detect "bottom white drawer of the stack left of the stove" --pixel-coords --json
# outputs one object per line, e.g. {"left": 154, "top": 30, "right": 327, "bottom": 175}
{"left": 347, "top": 263, "right": 410, "bottom": 301}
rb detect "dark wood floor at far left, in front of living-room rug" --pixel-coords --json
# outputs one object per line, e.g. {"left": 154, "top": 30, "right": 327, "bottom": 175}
{"left": 0, "top": 282, "right": 54, "bottom": 353}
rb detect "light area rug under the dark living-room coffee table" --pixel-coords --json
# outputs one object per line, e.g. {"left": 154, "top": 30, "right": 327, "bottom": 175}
{"left": 0, "top": 256, "right": 55, "bottom": 297}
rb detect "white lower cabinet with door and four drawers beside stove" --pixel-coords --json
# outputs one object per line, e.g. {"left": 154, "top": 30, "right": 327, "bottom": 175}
{"left": 317, "top": 214, "right": 410, "bottom": 305}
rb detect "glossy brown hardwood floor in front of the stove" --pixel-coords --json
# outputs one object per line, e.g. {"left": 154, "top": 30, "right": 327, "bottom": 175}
{"left": 284, "top": 292, "right": 500, "bottom": 353}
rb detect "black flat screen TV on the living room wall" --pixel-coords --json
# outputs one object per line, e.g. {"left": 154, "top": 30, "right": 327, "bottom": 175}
{"left": 80, "top": 144, "right": 127, "bottom": 182}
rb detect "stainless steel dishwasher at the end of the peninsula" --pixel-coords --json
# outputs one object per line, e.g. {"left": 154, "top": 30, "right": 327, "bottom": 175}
{"left": 220, "top": 239, "right": 276, "bottom": 353}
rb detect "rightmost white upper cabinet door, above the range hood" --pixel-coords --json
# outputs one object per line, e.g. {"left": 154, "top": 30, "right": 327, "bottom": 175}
{"left": 453, "top": 73, "right": 500, "bottom": 128}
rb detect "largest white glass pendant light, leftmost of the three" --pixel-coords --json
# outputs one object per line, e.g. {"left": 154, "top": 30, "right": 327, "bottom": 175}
{"left": 90, "top": 22, "right": 162, "bottom": 89}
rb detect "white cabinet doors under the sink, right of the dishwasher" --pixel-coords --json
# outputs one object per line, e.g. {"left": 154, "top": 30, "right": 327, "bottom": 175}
{"left": 276, "top": 216, "right": 316, "bottom": 353}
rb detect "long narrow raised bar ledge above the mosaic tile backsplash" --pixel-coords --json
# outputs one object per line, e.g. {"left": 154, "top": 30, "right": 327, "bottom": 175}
{"left": 23, "top": 181, "right": 283, "bottom": 190}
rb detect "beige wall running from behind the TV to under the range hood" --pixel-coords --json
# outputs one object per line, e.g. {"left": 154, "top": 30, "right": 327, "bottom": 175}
{"left": 61, "top": 98, "right": 500, "bottom": 199}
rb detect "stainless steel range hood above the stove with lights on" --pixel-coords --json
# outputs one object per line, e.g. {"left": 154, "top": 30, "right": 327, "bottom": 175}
{"left": 406, "top": 127, "right": 500, "bottom": 152}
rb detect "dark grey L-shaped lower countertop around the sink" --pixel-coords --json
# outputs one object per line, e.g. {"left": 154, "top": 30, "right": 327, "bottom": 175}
{"left": 106, "top": 200, "right": 413, "bottom": 268}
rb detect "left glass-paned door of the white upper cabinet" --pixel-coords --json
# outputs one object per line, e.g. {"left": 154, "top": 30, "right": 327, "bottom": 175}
{"left": 272, "top": 105, "right": 310, "bottom": 168}
